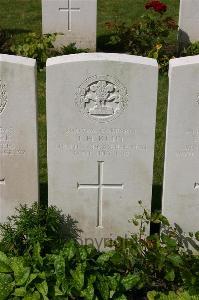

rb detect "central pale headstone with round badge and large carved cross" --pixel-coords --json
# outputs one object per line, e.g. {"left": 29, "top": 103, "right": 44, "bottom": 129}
{"left": 47, "top": 53, "right": 158, "bottom": 249}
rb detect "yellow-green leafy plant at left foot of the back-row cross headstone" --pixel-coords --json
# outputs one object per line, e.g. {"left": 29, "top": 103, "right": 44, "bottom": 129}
{"left": 11, "top": 33, "right": 57, "bottom": 70}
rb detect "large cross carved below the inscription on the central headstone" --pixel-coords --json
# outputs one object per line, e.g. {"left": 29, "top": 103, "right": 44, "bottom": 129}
{"left": 77, "top": 161, "right": 124, "bottom": 228}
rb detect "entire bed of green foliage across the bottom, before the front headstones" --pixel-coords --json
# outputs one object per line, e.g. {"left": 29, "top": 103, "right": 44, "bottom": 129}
{"left": 0, "top": 202, "right": 199, "bottom": 300}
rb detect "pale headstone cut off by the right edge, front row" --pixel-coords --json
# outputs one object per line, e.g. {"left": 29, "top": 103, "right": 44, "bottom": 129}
{"left": 162, "top": 56, "right": 199, "bottom": 232}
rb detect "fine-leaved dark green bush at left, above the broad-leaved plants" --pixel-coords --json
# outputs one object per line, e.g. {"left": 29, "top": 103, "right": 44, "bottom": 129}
{"left": 0, "top": 203, "right": 81, "bottom": 255}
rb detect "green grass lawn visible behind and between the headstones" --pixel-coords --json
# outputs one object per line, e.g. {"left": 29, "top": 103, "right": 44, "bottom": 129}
{"left": 0, "top": 0, "right": 179, "bottom": 207}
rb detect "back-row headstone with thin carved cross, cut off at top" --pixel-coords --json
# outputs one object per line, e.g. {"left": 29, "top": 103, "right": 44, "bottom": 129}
{"left": 42, "top": 0, "right": 97, "bottom": 51}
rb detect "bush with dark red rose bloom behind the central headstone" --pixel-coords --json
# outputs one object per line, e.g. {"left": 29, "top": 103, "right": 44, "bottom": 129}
{"left": 106, "top": 1, "right": 177, "bottom": 72}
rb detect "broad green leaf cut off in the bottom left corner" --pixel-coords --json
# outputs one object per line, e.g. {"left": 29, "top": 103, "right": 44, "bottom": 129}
{"left": 0, "top": 273, "right": 14, "bottom": 300}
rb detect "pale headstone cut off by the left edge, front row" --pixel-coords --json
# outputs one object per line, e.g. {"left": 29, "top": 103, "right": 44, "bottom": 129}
{"left": 0, "top": 54, "right": 38, "bottom": 222}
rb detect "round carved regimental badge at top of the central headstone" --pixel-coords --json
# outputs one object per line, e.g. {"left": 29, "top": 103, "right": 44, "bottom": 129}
{"left": 76, "top": 75, "right": 128, "bottom": 123}
